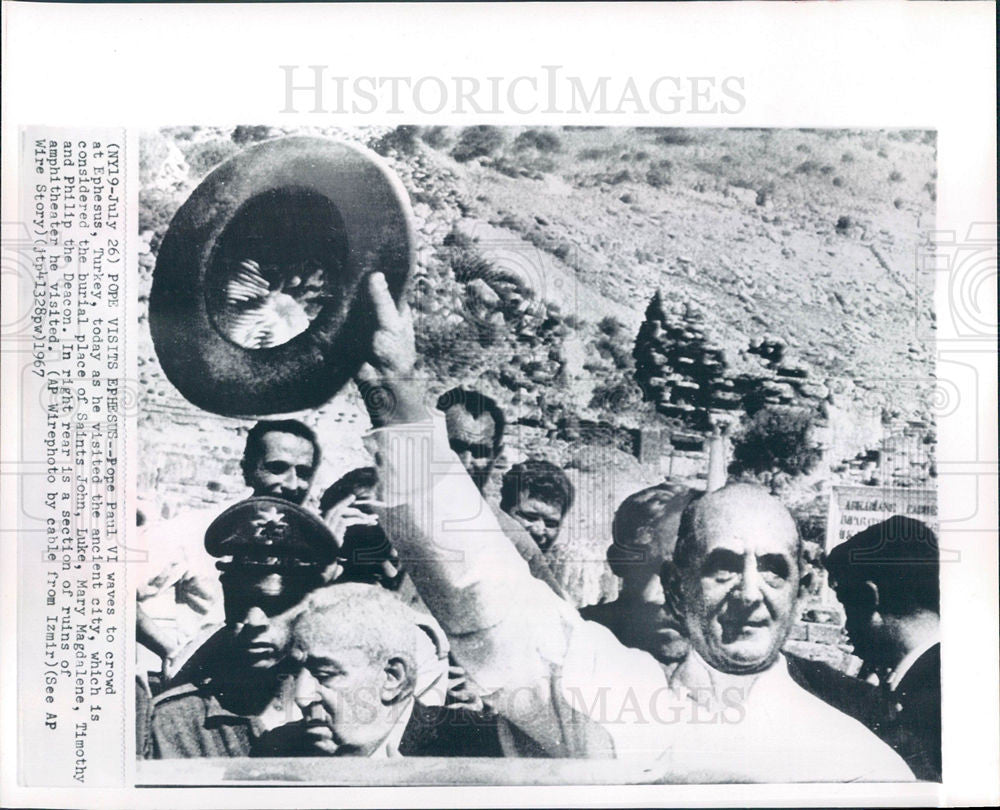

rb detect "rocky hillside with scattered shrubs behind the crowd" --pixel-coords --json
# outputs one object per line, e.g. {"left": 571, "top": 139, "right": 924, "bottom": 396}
{"left": 139, "top": 127, "right": 936, "bottom": 644}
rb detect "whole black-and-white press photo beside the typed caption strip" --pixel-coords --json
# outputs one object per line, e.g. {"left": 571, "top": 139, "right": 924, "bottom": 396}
{"left": 135, "top": 124, "right": 951, "bottom": 785}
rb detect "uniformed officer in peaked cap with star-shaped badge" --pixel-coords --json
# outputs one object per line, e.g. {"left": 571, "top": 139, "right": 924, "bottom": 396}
{"left": 145, "top": 497, "right": 336, "bottom": 759}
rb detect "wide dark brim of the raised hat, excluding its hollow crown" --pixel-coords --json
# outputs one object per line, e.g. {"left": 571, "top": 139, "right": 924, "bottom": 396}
{"left": 149, "top": 137, "right": 413, "bottom": 416}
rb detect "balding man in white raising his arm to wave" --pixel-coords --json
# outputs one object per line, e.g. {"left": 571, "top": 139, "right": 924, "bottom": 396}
{"left": 359, "top": 275, "right": 913, "bottom": 782}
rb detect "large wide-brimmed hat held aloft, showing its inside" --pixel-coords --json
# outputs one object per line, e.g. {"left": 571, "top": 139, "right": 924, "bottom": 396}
{"left": 149, "top": 137, "right": 413, "bottom": 416}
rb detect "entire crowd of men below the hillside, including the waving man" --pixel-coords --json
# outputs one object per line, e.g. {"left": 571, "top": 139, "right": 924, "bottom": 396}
{"left": 137, "top": 274, "right": 941, "bottom": 782}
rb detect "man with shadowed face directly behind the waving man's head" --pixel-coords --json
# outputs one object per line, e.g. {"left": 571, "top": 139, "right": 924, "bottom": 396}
{"left": 580, "top": 484, "right": 700, "bottom": 664}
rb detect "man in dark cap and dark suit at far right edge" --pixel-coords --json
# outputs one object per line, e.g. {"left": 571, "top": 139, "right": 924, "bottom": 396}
{"left": 826, "top": 515, "right": 941, "bottom": 782}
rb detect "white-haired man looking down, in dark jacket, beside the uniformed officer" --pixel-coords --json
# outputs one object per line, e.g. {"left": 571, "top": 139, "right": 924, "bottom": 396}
{"left": 253, "top": 583, "right": 501, "bottom": 759}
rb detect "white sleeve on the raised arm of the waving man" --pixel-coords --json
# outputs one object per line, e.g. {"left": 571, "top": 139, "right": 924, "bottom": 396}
{"left": 376, "top": 419, "right": 672, "bottom": 757}
